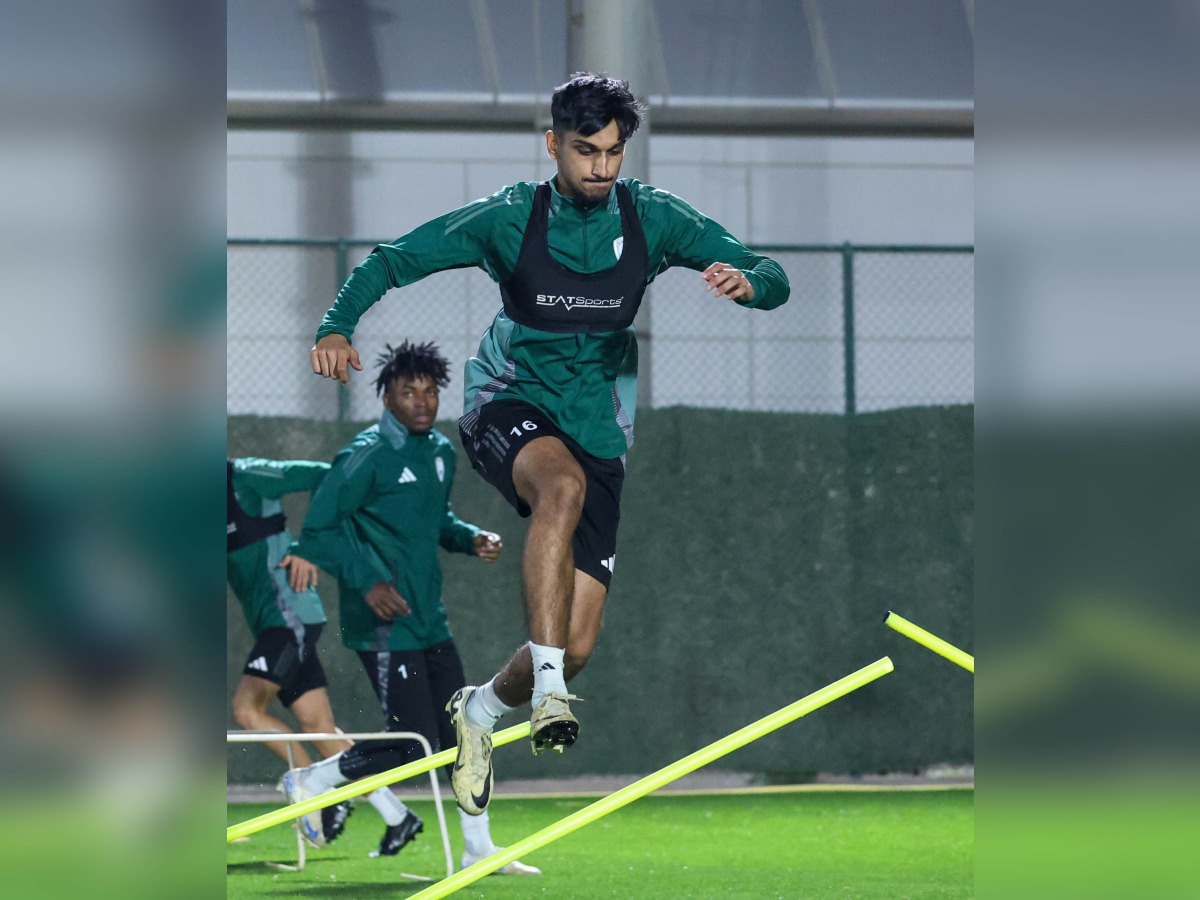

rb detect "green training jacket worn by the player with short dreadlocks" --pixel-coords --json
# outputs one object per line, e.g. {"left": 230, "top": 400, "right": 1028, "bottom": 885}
{"left": 292, "top": 410, "right": 480, "bottom": 652}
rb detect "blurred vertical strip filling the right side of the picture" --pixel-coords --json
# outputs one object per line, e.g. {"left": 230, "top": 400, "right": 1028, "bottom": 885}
{"left": 976, "top": 1, "right": 1200, "bottom": 899}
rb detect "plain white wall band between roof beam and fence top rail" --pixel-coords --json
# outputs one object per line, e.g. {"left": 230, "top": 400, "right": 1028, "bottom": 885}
{"left": 229, "top": 132, "right": 974, "bottom": 244}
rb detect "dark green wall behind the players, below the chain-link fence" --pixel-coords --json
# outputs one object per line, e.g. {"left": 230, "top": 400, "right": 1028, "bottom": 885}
{"left": 229, "top": 407, "right": 973, "bottom": 781}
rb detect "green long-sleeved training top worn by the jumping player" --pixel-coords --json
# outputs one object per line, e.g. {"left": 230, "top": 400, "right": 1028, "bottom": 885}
{"left": 317, "top": 179, "right": 791, "bottom": 458}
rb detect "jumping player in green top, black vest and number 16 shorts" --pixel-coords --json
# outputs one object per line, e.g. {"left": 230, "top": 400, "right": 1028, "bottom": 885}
{"left": 304, "top": 73, "right": 790, "bottom": 814}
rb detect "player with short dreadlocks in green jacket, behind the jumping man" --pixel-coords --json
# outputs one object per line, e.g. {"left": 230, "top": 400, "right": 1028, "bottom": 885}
{"left": 282, "top": 341, "right": 541, "bottom": 875}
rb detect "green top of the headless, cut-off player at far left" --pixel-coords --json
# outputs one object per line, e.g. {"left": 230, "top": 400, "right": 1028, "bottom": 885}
{"left": 226, "top": 457, "right": 329, "bottom": 642}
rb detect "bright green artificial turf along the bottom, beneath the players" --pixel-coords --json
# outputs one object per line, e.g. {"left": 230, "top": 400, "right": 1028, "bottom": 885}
{"left": 227, "top": 790, "right": 974, "bottom": 900}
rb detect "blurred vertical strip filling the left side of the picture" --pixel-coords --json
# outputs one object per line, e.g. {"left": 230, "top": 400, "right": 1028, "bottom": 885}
{"left": 0, "top": 0, "right": 224, "bottom": 900}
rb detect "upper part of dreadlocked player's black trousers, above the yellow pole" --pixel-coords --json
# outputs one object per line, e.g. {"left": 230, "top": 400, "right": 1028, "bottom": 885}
{"left": 359, "top": 641, "right": 467, "bottom": 750}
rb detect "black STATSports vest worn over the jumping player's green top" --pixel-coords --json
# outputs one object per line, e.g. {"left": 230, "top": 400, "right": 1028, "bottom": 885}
{"left": 500, "top": 181, "right": 647, "bottom": 334}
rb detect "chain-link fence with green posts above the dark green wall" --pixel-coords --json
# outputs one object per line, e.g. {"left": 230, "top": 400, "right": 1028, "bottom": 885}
{"left": 227, "top": 240, "right": 974, "bottom": 421}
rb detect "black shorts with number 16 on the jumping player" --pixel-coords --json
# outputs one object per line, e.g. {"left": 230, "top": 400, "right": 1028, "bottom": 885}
{"left": 458, "top": 400, "right": 625, "bottom": 588}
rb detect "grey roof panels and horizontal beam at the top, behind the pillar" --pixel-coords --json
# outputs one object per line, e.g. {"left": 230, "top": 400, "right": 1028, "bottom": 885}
{"left": 228, "top": 0, "right": 974, "bottom": 137}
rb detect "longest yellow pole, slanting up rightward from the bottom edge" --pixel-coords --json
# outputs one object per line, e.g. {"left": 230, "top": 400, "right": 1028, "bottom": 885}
{"left": 409, "top": 656, "right": 892, "bottom": 900}
